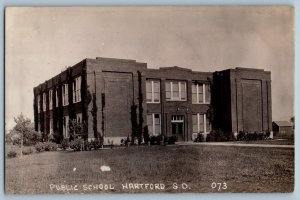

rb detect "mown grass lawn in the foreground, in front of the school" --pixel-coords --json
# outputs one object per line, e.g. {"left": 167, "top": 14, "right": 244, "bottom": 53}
{"left": 5, "top": 145, "right": 294, "bottom": 194}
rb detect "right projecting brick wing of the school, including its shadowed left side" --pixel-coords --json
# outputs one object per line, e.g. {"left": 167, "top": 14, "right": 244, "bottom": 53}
{"left": 213, "top": 68, "right": 272, "bottom": 132}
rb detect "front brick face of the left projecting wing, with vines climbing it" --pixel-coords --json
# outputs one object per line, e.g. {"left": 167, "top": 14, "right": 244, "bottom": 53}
{"left": 87, "top": 58, "right": 146, "bottom": 144}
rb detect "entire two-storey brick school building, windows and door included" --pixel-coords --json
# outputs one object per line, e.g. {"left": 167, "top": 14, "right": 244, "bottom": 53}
{"left": 34, "top": 57, "right": 272, "bottom": 144}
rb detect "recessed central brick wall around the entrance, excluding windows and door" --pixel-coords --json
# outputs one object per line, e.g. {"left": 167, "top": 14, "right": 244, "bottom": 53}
{"left": 146, "top": 67, "right": 212, "bottom": 141}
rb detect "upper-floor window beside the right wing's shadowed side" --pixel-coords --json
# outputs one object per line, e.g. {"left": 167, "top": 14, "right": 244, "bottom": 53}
{"left": 192, "top": 83, "right": 210, "bottom": 104}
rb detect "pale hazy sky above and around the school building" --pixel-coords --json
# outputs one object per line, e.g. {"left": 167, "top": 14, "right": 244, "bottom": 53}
{"left": 5, "top": 6, "right": 295, "bottom": 130}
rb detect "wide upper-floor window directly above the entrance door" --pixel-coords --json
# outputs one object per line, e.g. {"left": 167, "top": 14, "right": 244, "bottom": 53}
{"left": 166, "top": 81, "right": 187, "bottom": 101}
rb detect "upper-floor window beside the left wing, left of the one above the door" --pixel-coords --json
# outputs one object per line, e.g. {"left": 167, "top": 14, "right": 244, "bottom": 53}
{"left": 146, "top": 80, "right": 160, "bottom": 103}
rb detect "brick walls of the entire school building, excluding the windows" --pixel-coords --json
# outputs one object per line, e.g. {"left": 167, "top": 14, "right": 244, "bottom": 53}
{"left": 33, "top": 58, "right": 272, "bottom": 144}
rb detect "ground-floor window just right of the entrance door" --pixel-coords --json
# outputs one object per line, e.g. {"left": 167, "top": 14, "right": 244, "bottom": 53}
{"left": 192, "top": 113, "right": 211, "bottom": 137}
